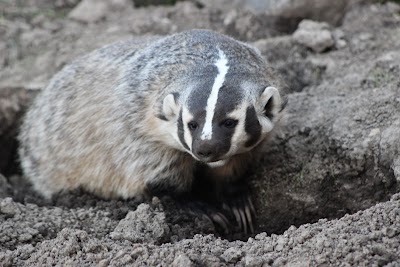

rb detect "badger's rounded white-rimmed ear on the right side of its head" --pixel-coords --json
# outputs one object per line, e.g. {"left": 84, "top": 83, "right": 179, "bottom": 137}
{"left": 259, "top": 86, "right": 282, "bottom": 132}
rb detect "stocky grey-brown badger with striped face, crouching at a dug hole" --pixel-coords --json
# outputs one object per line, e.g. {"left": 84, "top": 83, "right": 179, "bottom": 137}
{"left": 19, "top": 30, "right": 283, "bottom": 234}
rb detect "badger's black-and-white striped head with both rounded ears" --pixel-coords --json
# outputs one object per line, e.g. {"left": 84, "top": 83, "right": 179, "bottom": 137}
{"left": 162, "top": 49, "right": 282, "bottom": 167}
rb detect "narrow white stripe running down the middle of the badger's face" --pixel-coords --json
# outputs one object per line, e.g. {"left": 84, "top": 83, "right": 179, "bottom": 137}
{"left": 201, "top": 49, "right": 229, "bottom": 140}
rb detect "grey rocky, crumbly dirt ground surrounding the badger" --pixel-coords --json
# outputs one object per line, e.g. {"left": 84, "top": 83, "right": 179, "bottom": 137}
{"left": 0, "top": 0, "right": 400, "bottom": 266}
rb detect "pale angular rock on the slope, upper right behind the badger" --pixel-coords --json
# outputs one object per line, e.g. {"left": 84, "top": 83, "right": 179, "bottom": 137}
{"left": 293, "top": 20, "right": 335, "bottom": 53}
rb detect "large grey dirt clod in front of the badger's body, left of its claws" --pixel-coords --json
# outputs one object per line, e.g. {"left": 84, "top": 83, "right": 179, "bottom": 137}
{"left": 110, "top": 204, "right": 170, "bottom": 243}
